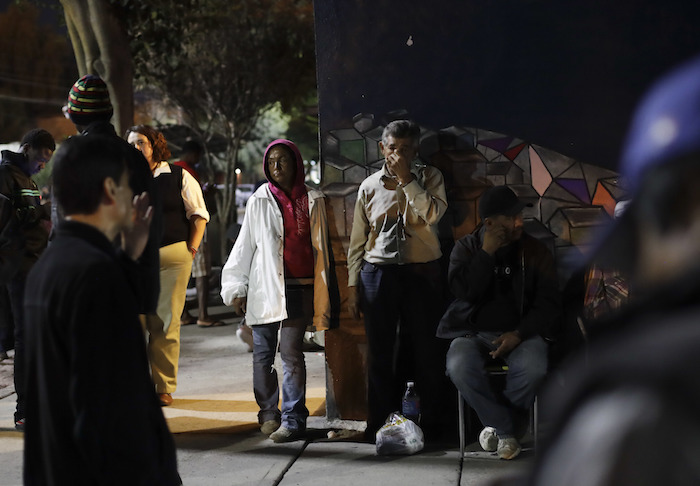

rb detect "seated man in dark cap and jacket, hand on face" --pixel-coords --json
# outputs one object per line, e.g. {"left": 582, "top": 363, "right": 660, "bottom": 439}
{"left": 438, "top": 186, "right": 561, "bottom": 459}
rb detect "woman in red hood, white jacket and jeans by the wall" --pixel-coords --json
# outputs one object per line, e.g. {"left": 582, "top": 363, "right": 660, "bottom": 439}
{"left": 221, "top": 140, "right": 331, "bottom": 442}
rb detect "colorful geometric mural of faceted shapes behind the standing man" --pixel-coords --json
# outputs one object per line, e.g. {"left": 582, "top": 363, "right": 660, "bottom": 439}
{"left": 321, "top": 112, "right": 624, "bottom": 280}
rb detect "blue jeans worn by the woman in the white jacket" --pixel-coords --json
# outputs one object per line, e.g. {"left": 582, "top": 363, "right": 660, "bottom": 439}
{"left": 250, "top": 284, "right": 313, "bottom": 431}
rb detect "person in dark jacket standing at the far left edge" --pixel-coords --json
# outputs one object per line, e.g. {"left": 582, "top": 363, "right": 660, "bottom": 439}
{"left": 0, "top": 129, "right": 56, "bottom": 430}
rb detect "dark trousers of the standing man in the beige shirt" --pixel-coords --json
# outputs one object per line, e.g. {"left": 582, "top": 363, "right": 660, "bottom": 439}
{"left": 360, "top": 261, "right": 449, "bottom": 437}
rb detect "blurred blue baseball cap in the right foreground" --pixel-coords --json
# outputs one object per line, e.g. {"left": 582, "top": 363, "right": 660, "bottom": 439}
{"left": 592, "top": 56, "right": 700, "bottom": 272}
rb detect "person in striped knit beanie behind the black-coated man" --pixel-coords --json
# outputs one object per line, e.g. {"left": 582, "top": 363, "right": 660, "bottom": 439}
{"left": 61, "top": 74, "right": 163, "bottom": 315}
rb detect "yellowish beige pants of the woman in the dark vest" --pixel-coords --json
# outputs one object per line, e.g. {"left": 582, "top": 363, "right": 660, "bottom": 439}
{"left": 146, "top": 241, "right": 192, "bottom": 393}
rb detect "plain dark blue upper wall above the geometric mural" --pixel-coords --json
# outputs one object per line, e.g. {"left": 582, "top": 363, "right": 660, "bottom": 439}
{"left": 314, "top": 0, "right": 700, "bottom": 168}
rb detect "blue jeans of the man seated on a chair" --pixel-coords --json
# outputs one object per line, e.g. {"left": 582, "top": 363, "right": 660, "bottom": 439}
{"left": 447, "top": 332, "right": 547, "bottom": 438}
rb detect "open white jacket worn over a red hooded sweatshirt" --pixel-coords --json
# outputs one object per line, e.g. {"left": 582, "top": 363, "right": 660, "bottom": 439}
{"left": 221, "top": 184, "right": 331, "bottom": 330}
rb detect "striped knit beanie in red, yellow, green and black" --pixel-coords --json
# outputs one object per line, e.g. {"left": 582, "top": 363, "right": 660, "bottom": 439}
{"left": 68, "top": 74, "right": 114, "bottom": 126}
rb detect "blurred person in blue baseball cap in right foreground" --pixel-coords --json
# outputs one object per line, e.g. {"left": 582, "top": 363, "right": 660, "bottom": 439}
{"left": 508, "top": 53, "right": 700, "bottom": 486}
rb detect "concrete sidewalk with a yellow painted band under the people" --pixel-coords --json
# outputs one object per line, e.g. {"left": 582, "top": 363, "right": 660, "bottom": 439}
{"left": 0, "top": 306, "right": 532, "bottom": 486}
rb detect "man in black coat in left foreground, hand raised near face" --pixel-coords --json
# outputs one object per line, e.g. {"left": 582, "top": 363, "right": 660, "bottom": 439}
{"left": 24, "top": 137, "right": 180, "bottom": 486}
